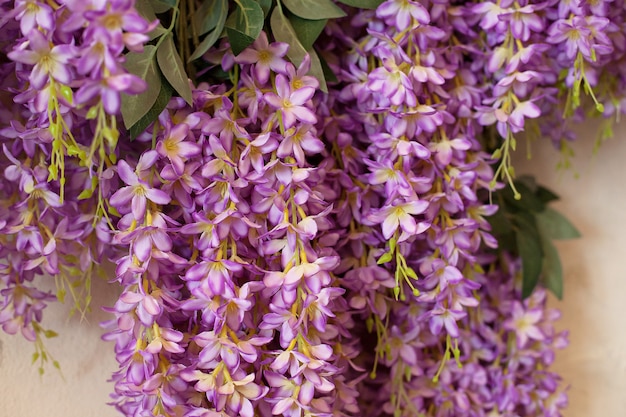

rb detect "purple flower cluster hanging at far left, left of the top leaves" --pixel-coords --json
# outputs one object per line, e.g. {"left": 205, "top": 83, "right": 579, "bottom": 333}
{"left": 0, "top": 0, "right": 149, "bottom": 361}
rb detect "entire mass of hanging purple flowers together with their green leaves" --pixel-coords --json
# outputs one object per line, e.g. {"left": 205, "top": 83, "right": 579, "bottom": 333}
{"left": 0, "top": 0, "right": 626, "bottom": 417}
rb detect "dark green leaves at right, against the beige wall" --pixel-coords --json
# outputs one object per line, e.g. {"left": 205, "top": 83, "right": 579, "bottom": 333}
{"left": 489, "top": 177, "right": 580, "bottom": 299}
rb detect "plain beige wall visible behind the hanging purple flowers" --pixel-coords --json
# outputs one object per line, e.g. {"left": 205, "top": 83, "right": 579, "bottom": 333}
{"left": 0, "top": 125, "right": 626, "bottom": 417}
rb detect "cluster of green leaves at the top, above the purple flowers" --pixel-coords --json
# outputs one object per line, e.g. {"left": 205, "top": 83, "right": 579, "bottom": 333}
{"left": 122, "top": 0, "right": 382, "bottom": 135}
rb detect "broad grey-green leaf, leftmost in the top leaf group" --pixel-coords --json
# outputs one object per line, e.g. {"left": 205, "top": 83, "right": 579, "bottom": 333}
{"left": 122, "top": 45, "right": 161, "bottom": 129}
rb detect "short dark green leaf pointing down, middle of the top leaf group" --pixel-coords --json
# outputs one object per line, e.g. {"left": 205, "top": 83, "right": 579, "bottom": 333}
{"left": 226, "top": 0, "right": 265, "bottom": 55}
